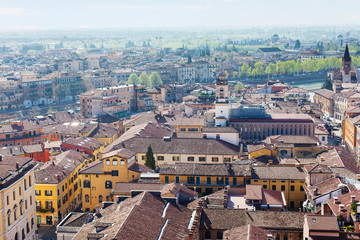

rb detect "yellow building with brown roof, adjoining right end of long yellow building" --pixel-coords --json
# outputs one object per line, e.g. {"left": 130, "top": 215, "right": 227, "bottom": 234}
{"left": 251, "top": 166, "right": 305, "bottom": 210}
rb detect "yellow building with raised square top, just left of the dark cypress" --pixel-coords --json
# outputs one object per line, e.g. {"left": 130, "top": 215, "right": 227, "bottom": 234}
{"left": 79, "top": 149, "right": 150, "bottom": 211}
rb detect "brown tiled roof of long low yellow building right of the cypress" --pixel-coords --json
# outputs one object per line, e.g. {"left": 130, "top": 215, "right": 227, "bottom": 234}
{"left": 159, "top": 163, "right": 251, "bottom": 176}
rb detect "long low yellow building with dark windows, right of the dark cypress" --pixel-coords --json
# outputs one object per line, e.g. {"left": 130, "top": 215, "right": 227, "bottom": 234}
{"left": 159, "top": 163, "right": 251, "bottom": 197}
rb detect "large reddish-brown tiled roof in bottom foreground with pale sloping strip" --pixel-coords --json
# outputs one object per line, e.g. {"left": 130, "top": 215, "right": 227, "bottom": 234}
{"left": 74, "top": 192, "right": 192, "bottom": 239}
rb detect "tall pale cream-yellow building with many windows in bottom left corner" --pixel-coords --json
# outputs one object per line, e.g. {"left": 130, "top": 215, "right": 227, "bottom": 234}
{"left": 0, "top": 156, "right": 37, "bottom": 240}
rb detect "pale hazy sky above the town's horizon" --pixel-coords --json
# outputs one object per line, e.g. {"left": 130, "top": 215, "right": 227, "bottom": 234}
{"left": 0, "top": 0, "right": 360, "bottom": 31}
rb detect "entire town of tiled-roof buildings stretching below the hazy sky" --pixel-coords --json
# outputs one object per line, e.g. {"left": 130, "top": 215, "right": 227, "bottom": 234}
{"left": 0, "top": 8, "right": 360, "bottom": 240}
